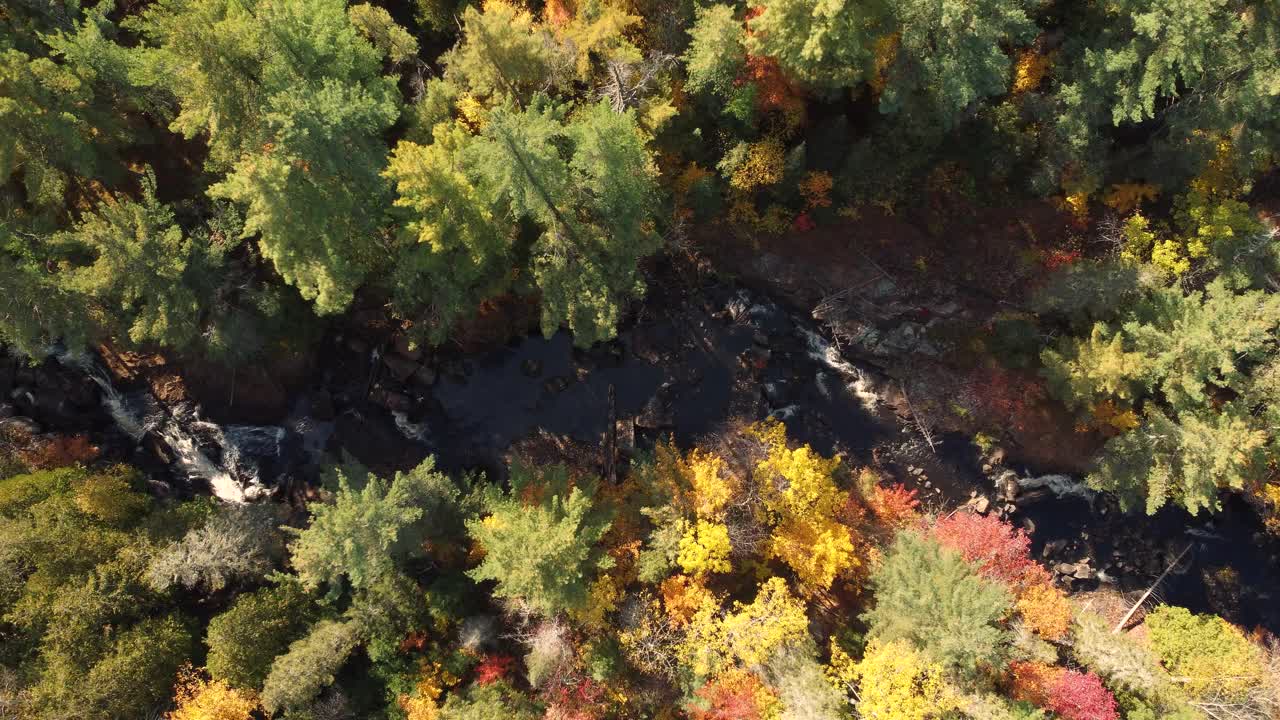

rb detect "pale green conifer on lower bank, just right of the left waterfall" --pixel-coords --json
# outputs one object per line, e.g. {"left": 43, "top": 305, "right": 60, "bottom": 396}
{"left": 289, "top": 459, "right": 457, "bottom": 594}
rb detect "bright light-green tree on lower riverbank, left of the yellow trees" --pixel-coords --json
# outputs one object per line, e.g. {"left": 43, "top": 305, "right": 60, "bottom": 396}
{"left": 467, "top": 466, "right": 612, "bottom": 615}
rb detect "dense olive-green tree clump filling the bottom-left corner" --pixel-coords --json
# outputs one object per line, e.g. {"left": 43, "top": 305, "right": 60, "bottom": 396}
{"left": 0, "top": 468, "right": 195, "bottom": 720}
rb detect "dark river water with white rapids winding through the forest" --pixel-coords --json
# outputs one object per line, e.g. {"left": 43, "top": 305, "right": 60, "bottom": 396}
{"left": 15, "top": 278, "right": 1280, "bottom": 632}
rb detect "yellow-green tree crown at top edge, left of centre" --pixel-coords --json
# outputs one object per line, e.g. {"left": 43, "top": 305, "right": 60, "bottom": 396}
{"left": 440, "top": 0, "right": 556, "bottom": 102}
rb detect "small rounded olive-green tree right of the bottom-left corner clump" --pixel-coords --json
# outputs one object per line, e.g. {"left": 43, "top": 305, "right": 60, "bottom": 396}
{"left": 205, "top": 580, "right": 315, "bottom": 691}
